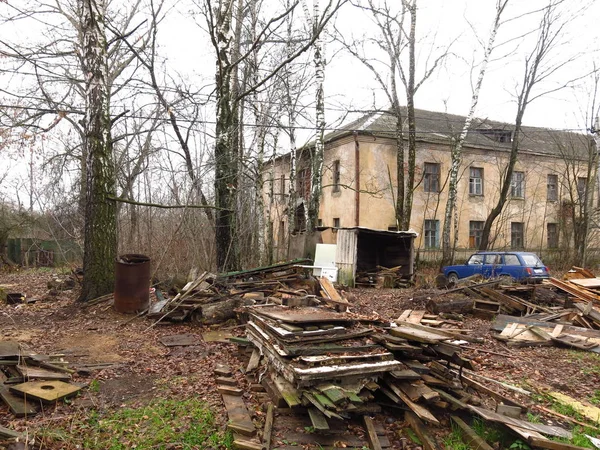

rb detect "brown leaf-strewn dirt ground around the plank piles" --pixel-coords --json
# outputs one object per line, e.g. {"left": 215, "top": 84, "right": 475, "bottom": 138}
{"left": 0, "top": 271, "right": 600, "bottom": 448}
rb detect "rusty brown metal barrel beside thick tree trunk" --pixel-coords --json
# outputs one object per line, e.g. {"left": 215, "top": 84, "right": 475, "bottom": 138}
{"left": 114, "top": 253, "right": 150, "bottom": 313}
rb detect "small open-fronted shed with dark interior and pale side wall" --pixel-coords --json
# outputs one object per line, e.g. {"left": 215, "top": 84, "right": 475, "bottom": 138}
{"left": 336, "top": 227, "right": 418, "bottom": 286}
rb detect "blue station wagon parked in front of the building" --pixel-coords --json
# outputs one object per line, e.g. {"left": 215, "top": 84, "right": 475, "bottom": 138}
{"left": 442, "top": 251, "right": 550, "bottom": 283}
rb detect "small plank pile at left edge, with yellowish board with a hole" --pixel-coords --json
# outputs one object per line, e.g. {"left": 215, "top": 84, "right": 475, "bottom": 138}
{"left": 0, "top": 341, "right": 81, "bottom": 417}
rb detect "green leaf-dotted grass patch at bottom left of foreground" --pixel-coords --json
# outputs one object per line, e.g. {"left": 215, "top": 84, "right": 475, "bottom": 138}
{"left": 35, "top": 399, "right": 233, "bottom": 450}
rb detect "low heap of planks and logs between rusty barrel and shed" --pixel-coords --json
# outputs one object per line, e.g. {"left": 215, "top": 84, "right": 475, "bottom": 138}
{"left": 148, "top": 260, "right": 347, "bottom": 324}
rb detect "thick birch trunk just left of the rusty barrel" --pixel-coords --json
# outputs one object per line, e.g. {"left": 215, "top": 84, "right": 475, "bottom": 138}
{"left": 79, "top": 0, "right": 117, "bottom": 301}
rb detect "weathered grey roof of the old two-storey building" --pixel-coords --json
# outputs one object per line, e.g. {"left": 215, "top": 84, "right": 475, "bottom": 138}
{"left": 324, "top": 107, "right": 590, "bottom": 159}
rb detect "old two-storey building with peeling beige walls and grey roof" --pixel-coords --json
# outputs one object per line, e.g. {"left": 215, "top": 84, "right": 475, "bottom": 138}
{"left": 265, "top": 110, "right": 595, "bottom": 257}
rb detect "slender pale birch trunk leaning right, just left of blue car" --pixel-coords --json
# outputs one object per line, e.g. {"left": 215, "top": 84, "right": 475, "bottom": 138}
{"left": 441, "top": 0, "right": 509, "bottom": 266}
